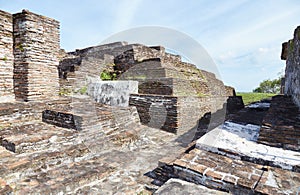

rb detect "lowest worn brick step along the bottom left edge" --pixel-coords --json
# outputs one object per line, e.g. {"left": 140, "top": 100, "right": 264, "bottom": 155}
{"left": 18, "top": 159, "right": 113, "bottom": 194}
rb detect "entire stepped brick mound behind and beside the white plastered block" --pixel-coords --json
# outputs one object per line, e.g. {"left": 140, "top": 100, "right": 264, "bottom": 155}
{"left": 59, "top": 42, "right": 235, "bottom": 134}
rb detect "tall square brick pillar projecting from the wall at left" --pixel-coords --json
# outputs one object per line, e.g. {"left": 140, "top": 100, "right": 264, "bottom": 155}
{"left": 13, "top": 10, "right": 60, "bottom": 101}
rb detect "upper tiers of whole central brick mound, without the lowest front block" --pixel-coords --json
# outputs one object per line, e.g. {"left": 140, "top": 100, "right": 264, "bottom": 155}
{"left": 60, "top": 44, "right": 227, "bottom": 97}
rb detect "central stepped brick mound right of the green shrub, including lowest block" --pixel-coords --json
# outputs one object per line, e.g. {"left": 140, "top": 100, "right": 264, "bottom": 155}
{"left": 114, "top": 45, "right": 230, "bottom": 135}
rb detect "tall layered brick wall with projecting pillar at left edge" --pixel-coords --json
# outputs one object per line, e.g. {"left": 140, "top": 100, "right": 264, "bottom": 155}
{"left": 0, "top": 10, "right": 60, "bottom": 101}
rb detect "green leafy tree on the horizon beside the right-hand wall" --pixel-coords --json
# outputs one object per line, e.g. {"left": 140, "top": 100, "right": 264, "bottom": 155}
{"left": 253, "top": 78, "right": 281, "bottom": 93}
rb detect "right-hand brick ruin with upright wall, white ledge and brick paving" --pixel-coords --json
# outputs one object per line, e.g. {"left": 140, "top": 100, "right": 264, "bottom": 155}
{"left": 151, "top": 27, "right": 300, "bottom": 194}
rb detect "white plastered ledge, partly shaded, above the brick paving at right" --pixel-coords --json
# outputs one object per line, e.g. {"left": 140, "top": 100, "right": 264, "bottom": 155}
{"left": 196, "top": 122, "right": 300, "bottom": 173}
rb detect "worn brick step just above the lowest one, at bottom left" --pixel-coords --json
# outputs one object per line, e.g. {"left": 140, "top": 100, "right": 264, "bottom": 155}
{"left": 0, "top": 144, "right": 89, "bottom": 183}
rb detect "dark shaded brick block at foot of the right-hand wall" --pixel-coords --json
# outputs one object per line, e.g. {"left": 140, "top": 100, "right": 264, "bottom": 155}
{"left": 258, "top": 95, "right": 300, "bottom": 152}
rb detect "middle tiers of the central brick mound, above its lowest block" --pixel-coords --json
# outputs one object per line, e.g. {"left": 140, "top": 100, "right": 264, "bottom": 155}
{"left": 119, "top": 58, "right": 226, "bottom": 97}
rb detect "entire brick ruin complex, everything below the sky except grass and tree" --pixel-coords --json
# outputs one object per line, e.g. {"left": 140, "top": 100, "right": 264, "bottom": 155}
{"left": 0, "top": 10, "right": 300, "bottom": 194}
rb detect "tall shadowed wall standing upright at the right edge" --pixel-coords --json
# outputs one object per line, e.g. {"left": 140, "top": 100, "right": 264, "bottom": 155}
{"left": 281, "top": 26, "right": 300, "bottom": 107}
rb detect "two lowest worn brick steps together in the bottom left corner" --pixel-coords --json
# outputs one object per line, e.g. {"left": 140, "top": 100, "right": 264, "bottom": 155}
{"left": 0, "top": 145, "right": 114, "bottom": 194}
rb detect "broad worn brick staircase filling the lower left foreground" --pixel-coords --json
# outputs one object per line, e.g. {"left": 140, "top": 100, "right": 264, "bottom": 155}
{"left": 0, "top": 98, "right": 151, "bottom": 194}
